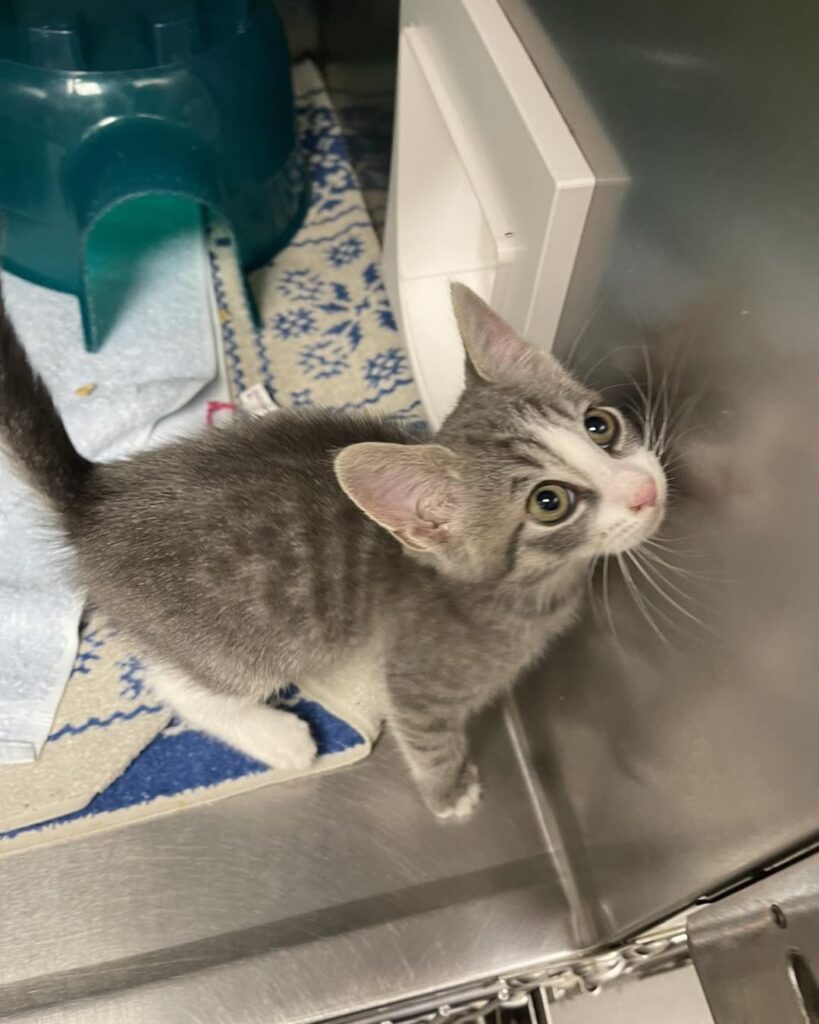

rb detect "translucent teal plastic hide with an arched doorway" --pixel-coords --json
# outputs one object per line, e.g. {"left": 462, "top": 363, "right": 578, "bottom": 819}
{"left": 0, "top": 0, "right": 309, "bottom": 351}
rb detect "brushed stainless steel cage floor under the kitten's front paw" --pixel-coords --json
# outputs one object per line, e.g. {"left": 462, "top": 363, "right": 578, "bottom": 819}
{"left": 0, "top": 714, "right": 577, "bottom": 1024}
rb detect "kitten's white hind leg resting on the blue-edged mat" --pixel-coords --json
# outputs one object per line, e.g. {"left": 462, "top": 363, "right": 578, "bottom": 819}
{"left": 150, "top": 666, "right": 316, "bottom": 771}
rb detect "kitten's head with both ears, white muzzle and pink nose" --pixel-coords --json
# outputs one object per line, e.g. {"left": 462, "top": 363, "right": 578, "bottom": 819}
{"left": 336, "top": 285, "right": 666, "bottom": 584}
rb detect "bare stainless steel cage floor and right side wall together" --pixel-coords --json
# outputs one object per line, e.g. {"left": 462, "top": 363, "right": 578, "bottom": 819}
{"left": 0, "top": 0, "right": 819, "bottom": 1024}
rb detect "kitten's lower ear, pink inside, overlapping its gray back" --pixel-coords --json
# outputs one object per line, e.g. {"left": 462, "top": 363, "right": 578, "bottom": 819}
{"left": 334, "top": 442, "right": 461, "bottom": 551}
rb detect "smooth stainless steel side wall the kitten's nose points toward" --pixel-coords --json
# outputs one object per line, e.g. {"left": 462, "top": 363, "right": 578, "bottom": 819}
{"left": 502, "top": 0, "right": 819, "bottom": 940}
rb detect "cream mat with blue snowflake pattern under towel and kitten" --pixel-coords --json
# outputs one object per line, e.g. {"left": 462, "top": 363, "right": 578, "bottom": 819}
{"left": 0, "top": 63, "right": 421, "bottom": 854}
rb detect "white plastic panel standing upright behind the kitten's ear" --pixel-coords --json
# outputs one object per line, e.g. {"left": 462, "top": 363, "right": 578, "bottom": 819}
{"left": 384, "top": 0, "right": 594, "bottom": 425}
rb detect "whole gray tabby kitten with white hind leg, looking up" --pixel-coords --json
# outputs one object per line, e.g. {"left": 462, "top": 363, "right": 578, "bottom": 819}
{"left": 0, "top": 285, "right": 665, "bottom": 818}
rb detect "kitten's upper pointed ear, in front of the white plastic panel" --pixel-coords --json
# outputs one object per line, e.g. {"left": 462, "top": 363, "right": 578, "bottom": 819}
{"left": 451, "top": 284, "right": 566, "bottom": 385}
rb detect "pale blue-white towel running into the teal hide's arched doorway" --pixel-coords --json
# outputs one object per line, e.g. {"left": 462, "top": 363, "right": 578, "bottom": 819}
{"left": 0, "top": 198, "right": 216, "bottom": 762}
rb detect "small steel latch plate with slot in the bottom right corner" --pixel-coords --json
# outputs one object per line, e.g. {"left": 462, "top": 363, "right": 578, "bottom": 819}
{"left": 688, "top": 854, "right": 819, "bottom": 1024}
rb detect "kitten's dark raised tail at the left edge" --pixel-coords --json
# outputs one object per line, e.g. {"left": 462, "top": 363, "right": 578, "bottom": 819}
{"left": 0, "top": 282, "right": 94, "bottom": 512}
